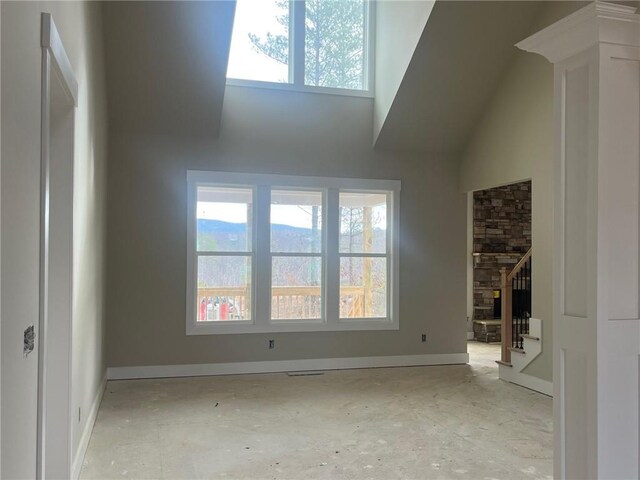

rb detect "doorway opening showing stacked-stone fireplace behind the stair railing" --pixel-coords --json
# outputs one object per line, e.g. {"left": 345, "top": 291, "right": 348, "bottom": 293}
{"left": 467, "top": 180, "right": 532, "bottom": 369}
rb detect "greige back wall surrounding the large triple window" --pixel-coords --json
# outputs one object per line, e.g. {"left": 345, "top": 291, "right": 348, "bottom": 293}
{"left": 107, "top": 86, "right": 466, "bottom": 367}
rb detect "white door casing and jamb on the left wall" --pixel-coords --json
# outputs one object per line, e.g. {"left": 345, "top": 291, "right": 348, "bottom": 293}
{"left": 37, "top": 13, "right": 78, "bottom": 478}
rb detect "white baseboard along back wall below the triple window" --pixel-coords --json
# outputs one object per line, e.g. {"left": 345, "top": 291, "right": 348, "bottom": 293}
{"left": 107, "top": 353, "right": 469, "bottom": 380}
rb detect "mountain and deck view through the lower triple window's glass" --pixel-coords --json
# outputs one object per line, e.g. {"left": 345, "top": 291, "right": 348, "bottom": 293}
{"left": 196, "top": 186, "right": 389, "bottom": 321}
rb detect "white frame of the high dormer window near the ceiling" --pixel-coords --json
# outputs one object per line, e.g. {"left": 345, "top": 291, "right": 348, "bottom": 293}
{"left": 227, "top": 0, "right": 376, "bottom": 98}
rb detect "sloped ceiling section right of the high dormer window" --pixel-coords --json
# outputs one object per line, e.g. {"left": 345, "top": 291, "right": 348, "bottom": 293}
{"left": 376, "top": 1, "right": 546, "bottom": 152}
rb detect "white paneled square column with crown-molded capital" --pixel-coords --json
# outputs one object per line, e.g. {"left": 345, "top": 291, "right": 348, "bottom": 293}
{"left": 518, "top": 2, "right": 640, "bottom": 479}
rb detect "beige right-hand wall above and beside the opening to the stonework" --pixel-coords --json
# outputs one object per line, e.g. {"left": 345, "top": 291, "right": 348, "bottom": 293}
{"left": 460, "top": 2, "right": 583, "bottom": 381}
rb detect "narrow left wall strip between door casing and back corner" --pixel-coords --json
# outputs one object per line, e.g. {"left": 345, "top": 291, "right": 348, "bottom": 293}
{"left": 71, "top": 2, "right": 107, "bottom": 470}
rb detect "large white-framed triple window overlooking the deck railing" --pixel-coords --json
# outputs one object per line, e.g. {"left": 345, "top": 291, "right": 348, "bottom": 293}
{"left": 187, "top": 171, "right": 400, "bottom": 334}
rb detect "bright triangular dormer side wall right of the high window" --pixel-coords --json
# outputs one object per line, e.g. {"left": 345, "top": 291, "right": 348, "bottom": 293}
{"left": 373, "top": 0, "right": 435, "bottom": 141}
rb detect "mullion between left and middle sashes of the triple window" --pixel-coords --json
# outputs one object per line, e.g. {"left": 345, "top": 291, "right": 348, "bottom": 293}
{"left": 253, "top": 185, "right": 271, "bottom": 325}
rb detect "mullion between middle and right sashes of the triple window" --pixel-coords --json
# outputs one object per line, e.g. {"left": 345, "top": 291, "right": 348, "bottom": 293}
{"left": 324, "top": 188, "right": 340, "bottom": 325}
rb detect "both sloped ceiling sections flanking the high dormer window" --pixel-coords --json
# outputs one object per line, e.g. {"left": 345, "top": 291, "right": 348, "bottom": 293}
{"left": 103, "top": 0, "right": 556, "bottom": 152}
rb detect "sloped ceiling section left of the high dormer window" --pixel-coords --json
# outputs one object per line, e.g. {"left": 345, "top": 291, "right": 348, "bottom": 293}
{"left": 103, "top": 1, "right": 235, "bottom": 137}
